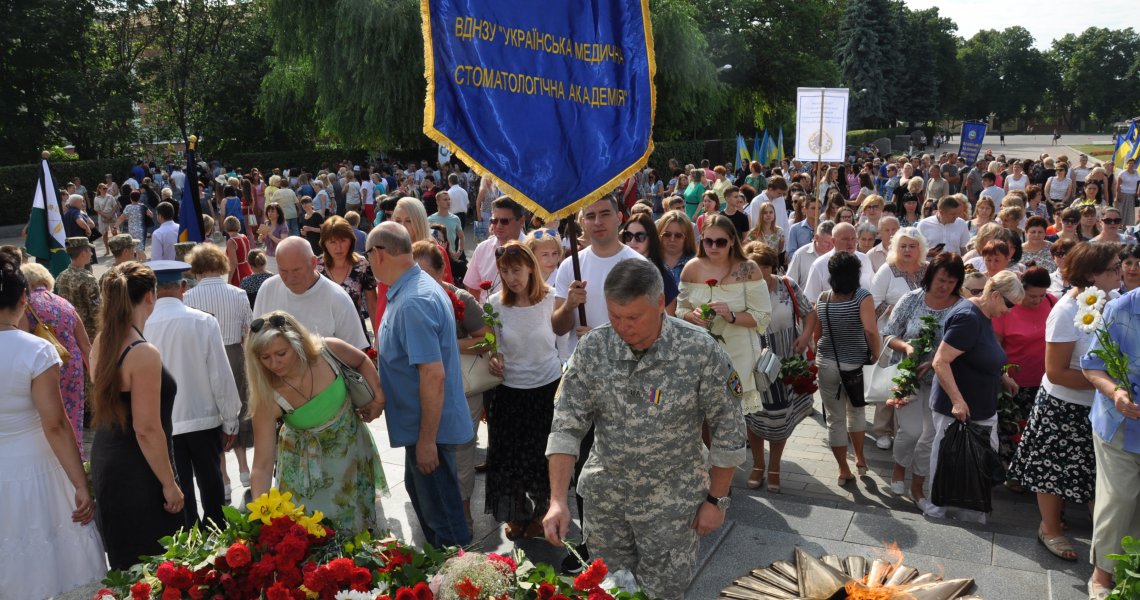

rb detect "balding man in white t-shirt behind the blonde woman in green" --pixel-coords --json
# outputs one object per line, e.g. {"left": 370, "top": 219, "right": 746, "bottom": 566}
{"left": 253, "top": 236, "right": 369, "bottom": 350}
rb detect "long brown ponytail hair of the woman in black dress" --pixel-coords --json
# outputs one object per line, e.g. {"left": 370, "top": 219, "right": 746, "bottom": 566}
{"left": 91, "top": 261, "right": 158, "bottom": 429}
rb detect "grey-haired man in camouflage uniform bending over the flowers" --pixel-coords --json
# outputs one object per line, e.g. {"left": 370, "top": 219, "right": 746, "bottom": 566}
{"left": 543, "top": 260, "right": 744, "bottom": 599}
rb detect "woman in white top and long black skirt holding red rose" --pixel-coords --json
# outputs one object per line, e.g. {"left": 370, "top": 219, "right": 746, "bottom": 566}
{"left": 485, "top": 241, "right": 562, "bottom": 540}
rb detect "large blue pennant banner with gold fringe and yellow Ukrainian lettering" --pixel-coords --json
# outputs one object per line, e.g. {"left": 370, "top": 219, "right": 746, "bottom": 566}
{"left": 421, "top": 0, "right": 656, "bottom": 218}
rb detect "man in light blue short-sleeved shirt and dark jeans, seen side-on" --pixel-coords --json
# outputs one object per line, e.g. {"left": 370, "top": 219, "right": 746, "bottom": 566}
{"left": 365, "top": 222, "right": 474, "bottom": 548}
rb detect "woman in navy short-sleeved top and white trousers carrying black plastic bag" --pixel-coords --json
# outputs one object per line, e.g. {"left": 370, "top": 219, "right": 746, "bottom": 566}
{"left": 923, "top": 270, "right": 1025, "bottom": 524}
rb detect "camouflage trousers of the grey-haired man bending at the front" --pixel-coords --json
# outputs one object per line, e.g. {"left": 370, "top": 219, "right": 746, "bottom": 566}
{"left": 584, "top": 498, "right": 700, "bottom": 600}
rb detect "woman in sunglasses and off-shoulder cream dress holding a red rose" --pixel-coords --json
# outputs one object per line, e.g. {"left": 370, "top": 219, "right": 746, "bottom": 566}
{"left": 677, "top": 214, "right": 772, "bottom": 415}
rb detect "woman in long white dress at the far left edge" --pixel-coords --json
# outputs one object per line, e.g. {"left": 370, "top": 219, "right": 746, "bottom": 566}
{"left": 0, "top": 252, "right": 107, "bottom": 598}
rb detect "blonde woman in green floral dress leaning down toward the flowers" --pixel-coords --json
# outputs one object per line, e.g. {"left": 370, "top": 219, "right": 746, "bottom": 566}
{"left": 245, "top": 310, "right": 388, "bottom": 532}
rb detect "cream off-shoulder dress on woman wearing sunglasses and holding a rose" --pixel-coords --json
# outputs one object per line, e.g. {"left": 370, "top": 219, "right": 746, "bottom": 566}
{"left": 677, "top": 279, "right": 772, "bottom": 414}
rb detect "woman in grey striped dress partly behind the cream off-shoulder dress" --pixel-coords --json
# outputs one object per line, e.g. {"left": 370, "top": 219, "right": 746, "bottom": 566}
{"left": 744, "top": 242, "right": 815, "bottom": 494}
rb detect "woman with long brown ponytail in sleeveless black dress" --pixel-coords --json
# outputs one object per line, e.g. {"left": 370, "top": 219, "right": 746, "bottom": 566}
{"left": 91, "top": 262, "right": 184, "bottom": 569}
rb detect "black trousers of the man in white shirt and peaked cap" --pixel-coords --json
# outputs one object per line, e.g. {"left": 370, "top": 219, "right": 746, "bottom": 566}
{"left": 174, "top": 425, "right": 229, "bottom": 527}
